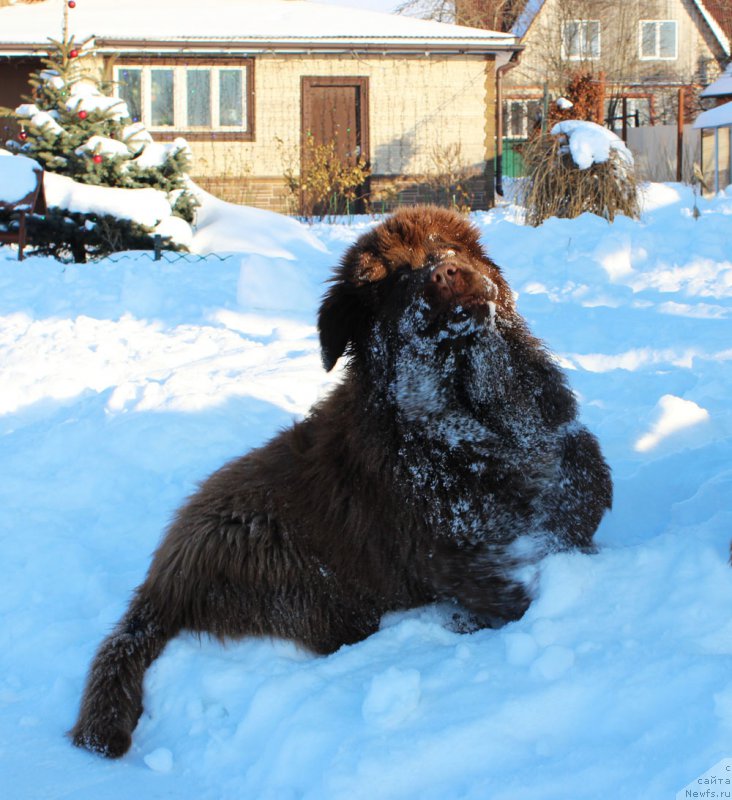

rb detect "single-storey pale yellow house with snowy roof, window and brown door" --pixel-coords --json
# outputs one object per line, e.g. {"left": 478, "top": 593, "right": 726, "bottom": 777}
{"left": 0, "top": 0, "right": 519, "bottom": 211}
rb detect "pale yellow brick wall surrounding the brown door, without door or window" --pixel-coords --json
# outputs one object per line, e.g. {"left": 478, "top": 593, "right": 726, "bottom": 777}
{"left": 182, "top": 55, "right": 495, "bottom": 211}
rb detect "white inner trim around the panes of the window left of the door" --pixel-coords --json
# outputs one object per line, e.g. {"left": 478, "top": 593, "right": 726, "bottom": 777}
{"left": 115, "top": 63, "right": 250, "bottom": 133}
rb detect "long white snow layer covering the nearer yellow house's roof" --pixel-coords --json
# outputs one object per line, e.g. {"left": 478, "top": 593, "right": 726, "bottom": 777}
{"left": 0, "top": 0, "right": 516, "bottom": 51}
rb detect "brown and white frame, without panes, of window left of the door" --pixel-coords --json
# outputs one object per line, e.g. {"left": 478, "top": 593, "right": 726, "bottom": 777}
{"left": 114, "top": 56, "right": 254, "bottom": 142}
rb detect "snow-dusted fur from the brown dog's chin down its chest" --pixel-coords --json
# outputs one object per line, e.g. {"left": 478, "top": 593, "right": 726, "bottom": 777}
{"left": 371, "top": 296, "right": 560, "bottom": 560}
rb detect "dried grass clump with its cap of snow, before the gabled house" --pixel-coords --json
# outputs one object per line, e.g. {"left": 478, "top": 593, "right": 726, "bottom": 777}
{"left": 520, "top": 120, "right": 640, "bottom": 226}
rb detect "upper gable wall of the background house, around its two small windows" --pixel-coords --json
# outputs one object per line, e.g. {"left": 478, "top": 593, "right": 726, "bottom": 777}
{"left": 506, "top": 0, "right": 726, "bottom": 122}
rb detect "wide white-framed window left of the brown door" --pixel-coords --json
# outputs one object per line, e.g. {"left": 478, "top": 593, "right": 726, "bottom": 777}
{"left": 115, "top": 59, "right": 253, "bottom": 139}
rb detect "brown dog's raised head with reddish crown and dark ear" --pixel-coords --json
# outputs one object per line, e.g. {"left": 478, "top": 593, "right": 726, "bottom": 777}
{"left": 318, "top": 206, "right": 513, "bottom": 370}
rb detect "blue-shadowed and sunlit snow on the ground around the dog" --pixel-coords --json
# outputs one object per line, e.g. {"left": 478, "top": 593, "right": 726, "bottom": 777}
{"left": 0, "top": 186, "right": 732, "bottom": 800}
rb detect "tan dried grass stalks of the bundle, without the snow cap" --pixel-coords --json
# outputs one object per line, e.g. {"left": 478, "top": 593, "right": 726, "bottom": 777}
{"left": 520, "top": 134, "right": 640, "bottom": 227}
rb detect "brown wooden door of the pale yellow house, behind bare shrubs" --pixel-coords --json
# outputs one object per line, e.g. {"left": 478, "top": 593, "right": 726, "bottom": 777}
{"left": 302, "top": 78, "right": 369, "bottom": 214}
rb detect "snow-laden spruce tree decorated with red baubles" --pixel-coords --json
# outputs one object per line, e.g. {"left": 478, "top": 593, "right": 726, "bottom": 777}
{"left": 2, "top": 0, "right": 196, "bottom": 261}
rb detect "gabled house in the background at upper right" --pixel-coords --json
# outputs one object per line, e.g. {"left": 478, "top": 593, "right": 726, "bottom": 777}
{"left": 457, "top": 0, "right": 732, "bottom": 137}
